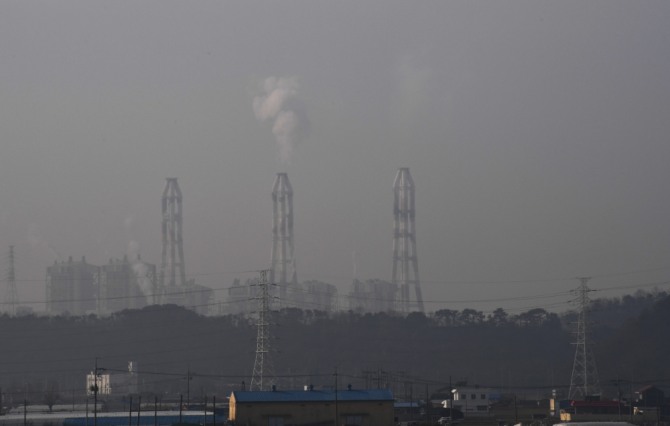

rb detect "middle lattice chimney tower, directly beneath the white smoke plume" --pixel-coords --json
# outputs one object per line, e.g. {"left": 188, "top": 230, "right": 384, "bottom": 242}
{"left": 270, "top": 173, "right": 298, "bottom": 306}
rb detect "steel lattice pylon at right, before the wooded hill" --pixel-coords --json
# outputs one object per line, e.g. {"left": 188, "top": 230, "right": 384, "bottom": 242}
{"left": 568, "top": 277, "right": 600, "bottom": 400}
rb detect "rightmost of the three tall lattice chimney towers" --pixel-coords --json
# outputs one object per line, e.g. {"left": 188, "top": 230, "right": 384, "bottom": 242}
{"left": 392, "top": 167, "right": 423, "bottom": 312}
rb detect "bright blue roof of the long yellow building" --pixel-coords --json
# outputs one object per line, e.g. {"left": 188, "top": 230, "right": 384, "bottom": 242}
{"left": 231, "top": 389, "right": 393, "bottom": 403}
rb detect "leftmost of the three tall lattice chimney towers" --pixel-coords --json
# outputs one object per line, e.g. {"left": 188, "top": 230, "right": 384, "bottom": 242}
{"left": 159, "top": 178, "right": 186, "bottom": 303}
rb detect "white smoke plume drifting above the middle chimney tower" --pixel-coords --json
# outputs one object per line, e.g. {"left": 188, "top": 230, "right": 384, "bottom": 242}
{"left": 253, "top": 77, "right": 309, "bottom": 163}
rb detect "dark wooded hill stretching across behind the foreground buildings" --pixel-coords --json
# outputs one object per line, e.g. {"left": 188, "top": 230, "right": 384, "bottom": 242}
{"left": 0, "top": 292, "right": 670, "bottom": 405}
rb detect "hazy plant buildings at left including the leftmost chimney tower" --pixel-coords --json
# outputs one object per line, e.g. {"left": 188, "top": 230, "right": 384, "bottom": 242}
{"left": 46, "top": 178, "right": 213, "bottom": 315}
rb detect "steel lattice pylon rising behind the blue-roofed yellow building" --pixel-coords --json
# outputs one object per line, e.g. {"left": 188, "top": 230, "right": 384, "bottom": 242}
{"left": 249, "top": 271, "right": 274, "bottom": 390}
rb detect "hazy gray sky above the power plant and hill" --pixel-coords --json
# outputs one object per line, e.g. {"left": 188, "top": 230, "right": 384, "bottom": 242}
{"left": 0, "top": 0, "right": 670, "bottom": 310}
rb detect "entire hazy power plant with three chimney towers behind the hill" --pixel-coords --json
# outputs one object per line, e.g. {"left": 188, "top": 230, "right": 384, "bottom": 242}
{"left": 38, "top": 171, "right": 424, "bottom": 315}
